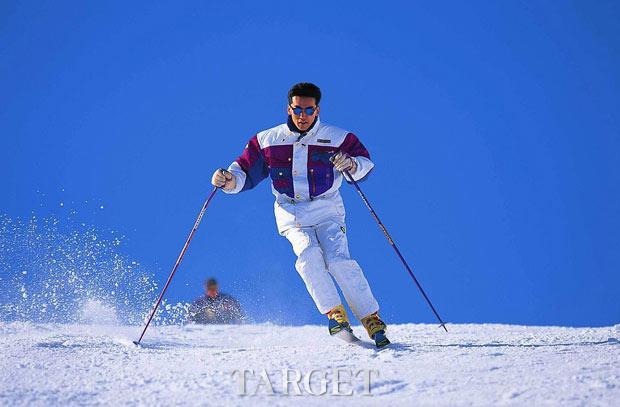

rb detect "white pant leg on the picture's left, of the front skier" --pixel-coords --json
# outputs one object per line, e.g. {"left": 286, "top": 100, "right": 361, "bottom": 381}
{"left": 284, "top": 228, "right": 342, "bottom": 314}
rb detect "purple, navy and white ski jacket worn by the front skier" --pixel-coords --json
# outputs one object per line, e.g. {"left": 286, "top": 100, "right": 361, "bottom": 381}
{"left": 224, "top": 118, "right": 374, "bottom": 234}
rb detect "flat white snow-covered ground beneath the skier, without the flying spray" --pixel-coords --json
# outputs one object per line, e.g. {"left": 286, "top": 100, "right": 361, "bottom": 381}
{"left": 0, "top": 324, "right": 620, "bottom": 407}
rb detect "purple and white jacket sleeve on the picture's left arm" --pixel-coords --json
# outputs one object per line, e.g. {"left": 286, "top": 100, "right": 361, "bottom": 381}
{"left": 223, "top": 136, "right": 269, "bottom": 194}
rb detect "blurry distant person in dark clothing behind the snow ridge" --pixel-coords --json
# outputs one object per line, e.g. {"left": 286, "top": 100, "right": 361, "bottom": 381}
{"left": 188, "top": 278, "right": 244, "bottom": 324}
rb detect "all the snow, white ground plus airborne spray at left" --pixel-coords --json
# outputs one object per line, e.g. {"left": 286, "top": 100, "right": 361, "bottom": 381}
{"left": 0, "top": 214, "right": 620, "bottom": 407}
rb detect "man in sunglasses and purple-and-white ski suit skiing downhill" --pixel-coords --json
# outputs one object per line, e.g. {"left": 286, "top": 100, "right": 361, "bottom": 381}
{"left": 211, "top": 83, "right": 390, "bottom": 348}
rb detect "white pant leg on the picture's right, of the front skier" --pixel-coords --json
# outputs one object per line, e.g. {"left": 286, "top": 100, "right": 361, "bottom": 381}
{"left": 316, "top": 221, "right": 379, "bottom": 320}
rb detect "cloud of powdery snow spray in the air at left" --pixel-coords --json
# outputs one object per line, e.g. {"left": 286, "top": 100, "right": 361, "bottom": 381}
{"left": 0, "top": 211, "right": 188, "bottom": 325}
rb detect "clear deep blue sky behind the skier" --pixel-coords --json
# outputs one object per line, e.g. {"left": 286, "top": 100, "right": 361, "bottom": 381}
{"left": 0, "top": 1, "right": 620, "bottom": 325}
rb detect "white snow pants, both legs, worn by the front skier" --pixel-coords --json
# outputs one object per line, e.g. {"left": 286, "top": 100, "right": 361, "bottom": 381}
{"left": 283, "top": 221, "right": 379, "bottom": 320}
